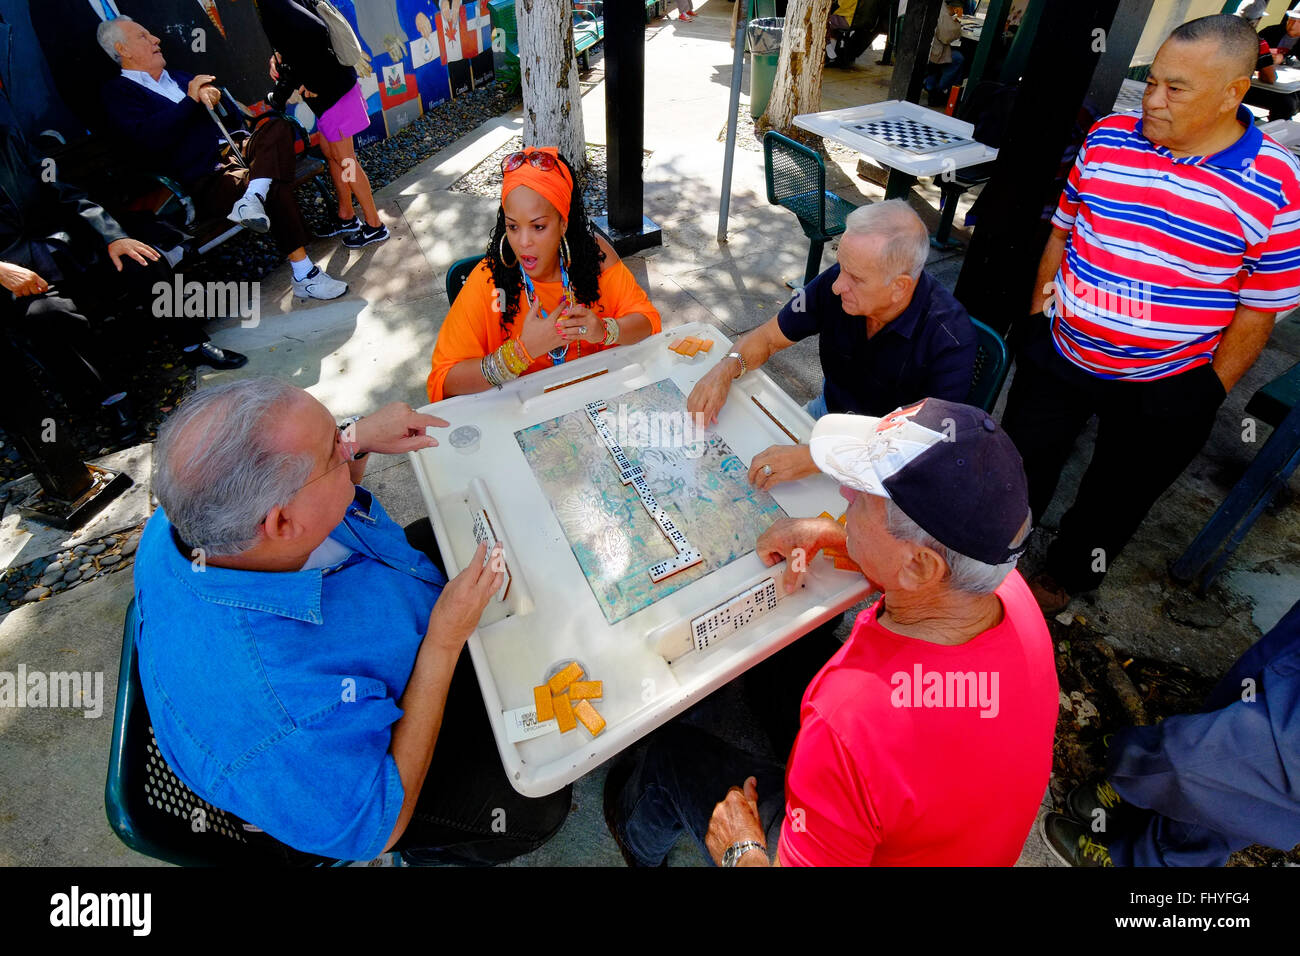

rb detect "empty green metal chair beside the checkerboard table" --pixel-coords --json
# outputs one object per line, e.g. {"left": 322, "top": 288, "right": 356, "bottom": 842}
{"left": 763, "top": 130, "right": 858, "bottom": 285}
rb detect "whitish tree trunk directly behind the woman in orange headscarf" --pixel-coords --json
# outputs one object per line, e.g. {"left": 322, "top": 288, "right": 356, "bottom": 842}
{"left": 515, "top": 0, "right": 586, "bottom": 173}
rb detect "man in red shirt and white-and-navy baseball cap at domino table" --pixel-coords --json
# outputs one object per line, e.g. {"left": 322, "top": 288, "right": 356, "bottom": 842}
{"left": 606, "top": 398, "right": 1058, "bottom": 866}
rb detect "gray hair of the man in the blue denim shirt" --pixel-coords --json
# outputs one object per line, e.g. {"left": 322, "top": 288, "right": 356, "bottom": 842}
{"left": 153, "top": 378, "right": 316, "bottom": 557}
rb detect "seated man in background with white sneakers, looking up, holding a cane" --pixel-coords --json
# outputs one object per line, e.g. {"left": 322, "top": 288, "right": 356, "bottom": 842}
{"left": 98, "top": 17, "right": 347, "bottom": 299}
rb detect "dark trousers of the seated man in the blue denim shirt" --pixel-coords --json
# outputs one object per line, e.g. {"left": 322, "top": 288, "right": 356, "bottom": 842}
{"left": 394, "top": 518, "right": 572, "bottom": 865}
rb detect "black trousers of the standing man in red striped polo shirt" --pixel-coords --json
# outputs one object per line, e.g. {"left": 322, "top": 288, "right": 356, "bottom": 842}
{"left": 1002, "top": 315, "right": 1226, "bottom": 594}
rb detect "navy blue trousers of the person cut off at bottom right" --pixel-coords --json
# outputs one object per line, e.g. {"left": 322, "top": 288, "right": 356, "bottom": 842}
{"left": 1108, "top": 604, "right": 1300, "bottom": 866}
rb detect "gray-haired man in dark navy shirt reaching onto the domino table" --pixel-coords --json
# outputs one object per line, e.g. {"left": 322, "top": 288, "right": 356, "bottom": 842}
{"left": 686, "top": 199, "right": 976, "bottom": 489}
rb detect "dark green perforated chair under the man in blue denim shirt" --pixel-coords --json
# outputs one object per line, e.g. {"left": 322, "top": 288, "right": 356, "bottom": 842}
{"left": 104, "top": 598, "right": 332, "bottom": 866}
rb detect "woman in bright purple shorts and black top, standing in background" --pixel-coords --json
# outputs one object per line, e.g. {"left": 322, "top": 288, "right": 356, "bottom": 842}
{"left": 254, "top": 0, "right": 389, "bottom": 248}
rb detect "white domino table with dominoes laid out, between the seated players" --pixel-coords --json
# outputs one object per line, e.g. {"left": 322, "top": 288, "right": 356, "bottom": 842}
{"left": 411, "top": 324, "right": 868, "bottom": 797}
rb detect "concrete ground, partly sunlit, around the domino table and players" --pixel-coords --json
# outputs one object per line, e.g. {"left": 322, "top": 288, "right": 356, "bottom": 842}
{"left": 0, "top": 0, "right": 1300, "bottom": 865}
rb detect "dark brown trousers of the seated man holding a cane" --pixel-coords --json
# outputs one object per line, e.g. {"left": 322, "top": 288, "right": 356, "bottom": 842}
{"left": 194, "top": 117, "right": 307, "bottom": 252}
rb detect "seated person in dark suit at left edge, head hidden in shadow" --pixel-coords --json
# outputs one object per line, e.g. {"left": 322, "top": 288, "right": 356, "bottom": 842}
{"left": 0, "top": 124, "right": 247, "bottom": 441}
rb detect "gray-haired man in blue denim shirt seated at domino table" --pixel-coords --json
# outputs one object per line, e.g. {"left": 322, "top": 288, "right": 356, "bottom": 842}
{"left": 135, "top": 378, "right": 569, "bottom": 862}
